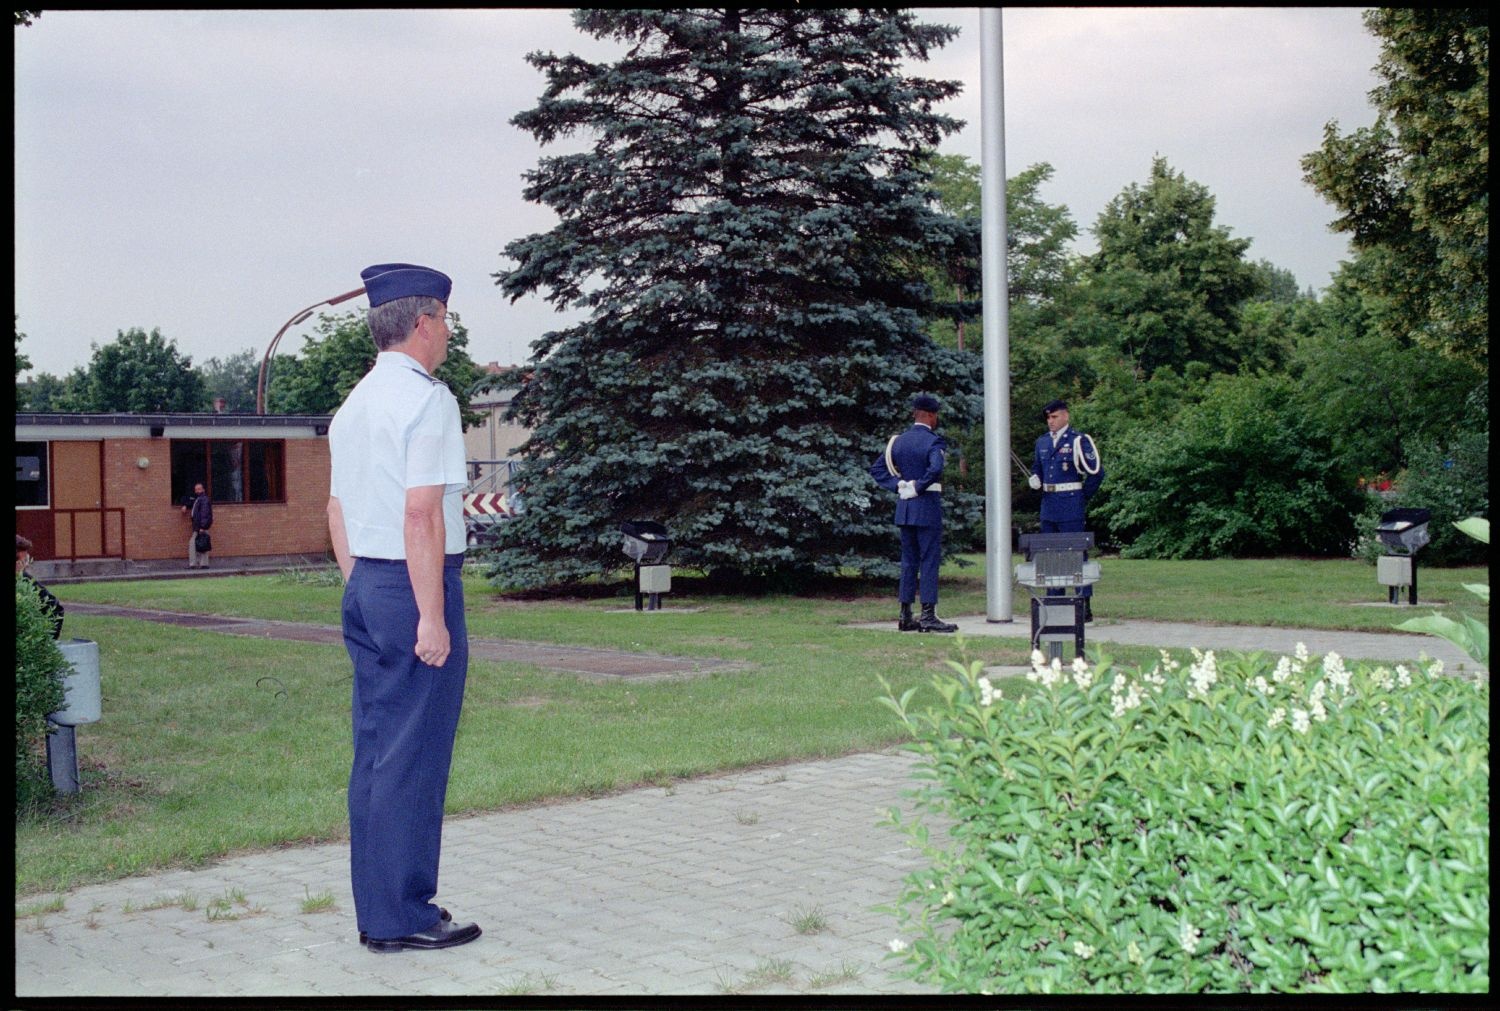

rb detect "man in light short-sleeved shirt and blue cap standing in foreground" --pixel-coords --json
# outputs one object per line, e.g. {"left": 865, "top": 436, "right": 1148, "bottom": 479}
{"left": 329, "top": 264, "right": 480, "bottom": 951}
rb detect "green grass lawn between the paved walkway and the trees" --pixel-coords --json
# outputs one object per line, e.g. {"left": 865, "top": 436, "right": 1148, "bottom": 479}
{"left": 15, "top": 558, "right": 1488, "bottom": 899}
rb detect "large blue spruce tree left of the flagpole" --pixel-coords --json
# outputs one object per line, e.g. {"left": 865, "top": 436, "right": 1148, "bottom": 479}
{"left": 492, "top": 9, "right": 981, "bottom": 587}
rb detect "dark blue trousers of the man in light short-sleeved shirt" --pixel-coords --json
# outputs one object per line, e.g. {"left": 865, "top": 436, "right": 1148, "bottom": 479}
{"left": 344, "top": 555, "right": 468, "bottom": 938}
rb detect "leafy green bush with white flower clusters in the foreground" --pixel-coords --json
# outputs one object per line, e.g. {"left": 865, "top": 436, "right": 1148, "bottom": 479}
{"left": 882, "top": 647, "right": 1490, "bottom": 993}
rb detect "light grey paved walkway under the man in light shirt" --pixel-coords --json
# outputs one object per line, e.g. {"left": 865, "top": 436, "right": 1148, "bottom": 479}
{"left": 15, "top": 755, "right": 930, "bottom": 998}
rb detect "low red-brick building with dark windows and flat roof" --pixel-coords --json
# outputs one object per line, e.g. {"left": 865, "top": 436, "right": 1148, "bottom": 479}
{"left": 15, "top": 413, "right": 332, "bottom": 570}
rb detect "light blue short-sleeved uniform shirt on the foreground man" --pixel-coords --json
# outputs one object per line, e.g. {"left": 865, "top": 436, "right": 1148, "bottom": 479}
{"left": 329, "top": 351, "right": 468, "bottom": 558}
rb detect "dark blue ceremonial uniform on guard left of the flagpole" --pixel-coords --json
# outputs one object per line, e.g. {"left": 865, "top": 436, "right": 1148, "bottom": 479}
{"left": 870, "top": 425, "right": 948, "bottom": 606}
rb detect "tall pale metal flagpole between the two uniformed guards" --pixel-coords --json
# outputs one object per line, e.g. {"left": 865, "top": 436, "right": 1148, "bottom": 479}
{"left": 980, "top": 8, "right": 1014, "bottom": 621}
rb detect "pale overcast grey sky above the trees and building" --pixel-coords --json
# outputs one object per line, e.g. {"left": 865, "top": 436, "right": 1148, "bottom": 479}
{"left": 15, "top": 8, "right": 1379, "bottom": 382}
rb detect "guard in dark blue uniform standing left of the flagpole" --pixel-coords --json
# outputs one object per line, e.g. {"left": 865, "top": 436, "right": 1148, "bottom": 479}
{"left": 870, "top": 393, "right": 959, "bottom": 632}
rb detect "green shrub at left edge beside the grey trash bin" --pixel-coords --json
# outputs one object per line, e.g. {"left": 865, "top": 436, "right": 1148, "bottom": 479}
{"left": 15, "top": 578, "right": 69, "bottom": 810}
